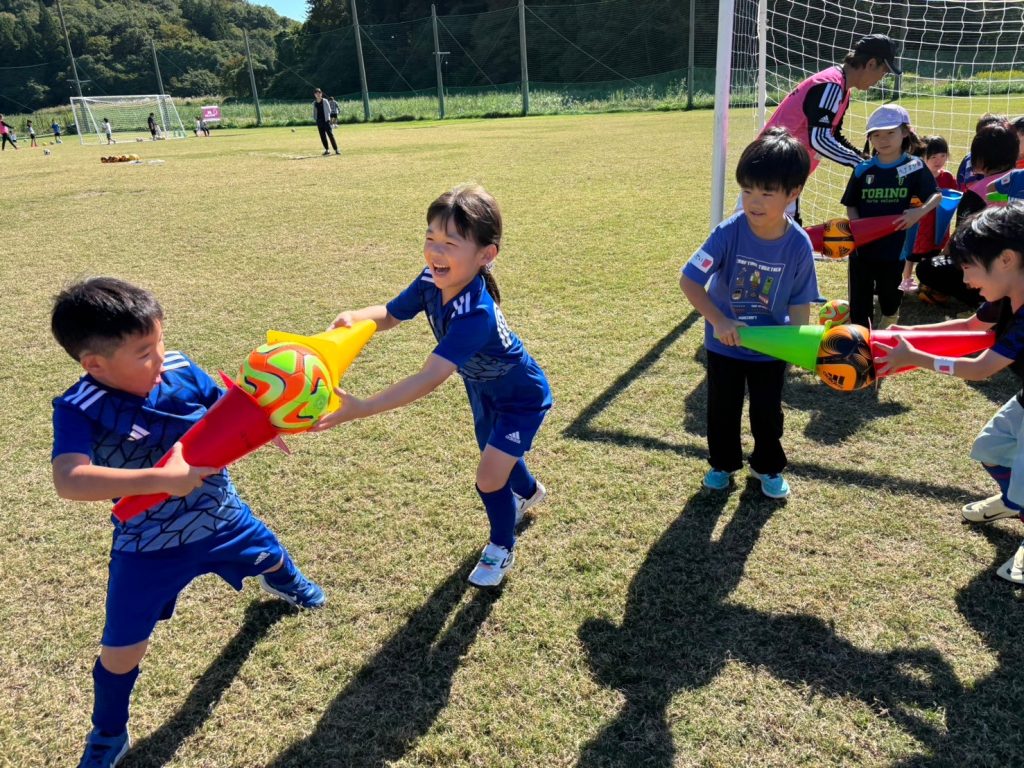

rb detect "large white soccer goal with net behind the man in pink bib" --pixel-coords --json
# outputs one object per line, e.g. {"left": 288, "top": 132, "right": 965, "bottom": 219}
{"left": 712, "top": 0, "right": 1024, "bottom": 226}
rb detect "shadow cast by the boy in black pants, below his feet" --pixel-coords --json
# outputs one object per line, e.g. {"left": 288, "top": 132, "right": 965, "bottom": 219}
{"left": 579, "top": 489, "right": 959, "bottom": 768}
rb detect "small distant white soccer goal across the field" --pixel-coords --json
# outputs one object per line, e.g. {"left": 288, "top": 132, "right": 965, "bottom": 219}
{"left": 71, "top": 95, "right": 185, "bottom": 144}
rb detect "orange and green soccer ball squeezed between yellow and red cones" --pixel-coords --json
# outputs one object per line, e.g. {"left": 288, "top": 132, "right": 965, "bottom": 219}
{"left": 238, "top": 344, "right": 331, "bottom": 432}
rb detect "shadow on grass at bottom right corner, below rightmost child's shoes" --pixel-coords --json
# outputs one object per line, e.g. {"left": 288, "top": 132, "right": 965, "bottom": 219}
{"left": 898, "top": 526, "right": 1024, "bottom": 768}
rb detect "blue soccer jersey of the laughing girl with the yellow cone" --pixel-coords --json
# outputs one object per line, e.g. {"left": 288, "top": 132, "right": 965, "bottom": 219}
{"left": 387, "top": 267, "right": 550, "bottom": 396}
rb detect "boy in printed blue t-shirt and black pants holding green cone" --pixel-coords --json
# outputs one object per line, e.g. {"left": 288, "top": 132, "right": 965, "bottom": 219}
{"left": 679, "top": 128, "right": 818, "bottom": 499}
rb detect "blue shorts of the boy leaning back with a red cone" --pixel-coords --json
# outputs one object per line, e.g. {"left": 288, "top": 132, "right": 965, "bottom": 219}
{"left": 101, "top": 508, "right": 285, "bottom": 647}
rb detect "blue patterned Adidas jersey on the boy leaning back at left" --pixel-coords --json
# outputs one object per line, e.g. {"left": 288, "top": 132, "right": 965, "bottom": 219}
{"left": 52, "top": 352, "right": 248, "bottom": 552}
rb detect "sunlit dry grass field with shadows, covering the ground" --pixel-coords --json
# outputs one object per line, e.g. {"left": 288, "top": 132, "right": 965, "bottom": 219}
{"left": 0, "top": 113, "right": 1024, "bottom": 768}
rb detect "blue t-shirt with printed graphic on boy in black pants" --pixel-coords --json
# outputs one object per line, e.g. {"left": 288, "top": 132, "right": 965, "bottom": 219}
{"left": 683, "top": 211, "right": 818, "bottom": 362}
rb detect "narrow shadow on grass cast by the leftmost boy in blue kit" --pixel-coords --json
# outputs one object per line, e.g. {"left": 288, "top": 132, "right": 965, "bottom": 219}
{"left": 127, "top": 600, "right": 298, "bottom": 768}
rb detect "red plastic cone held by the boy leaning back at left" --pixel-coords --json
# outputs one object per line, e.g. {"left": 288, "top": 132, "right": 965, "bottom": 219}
{"left": 114, "top": 374, "right": 278, "bottom": 522}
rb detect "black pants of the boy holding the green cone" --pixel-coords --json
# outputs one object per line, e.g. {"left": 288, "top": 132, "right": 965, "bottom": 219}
{"left": 707, "top": 349, "right": 786, "bottom": 475}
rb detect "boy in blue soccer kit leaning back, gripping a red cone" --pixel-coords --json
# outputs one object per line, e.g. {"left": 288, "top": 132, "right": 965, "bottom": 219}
{"left": 51, "top": 278, "right": 324, "bottom": 768}
